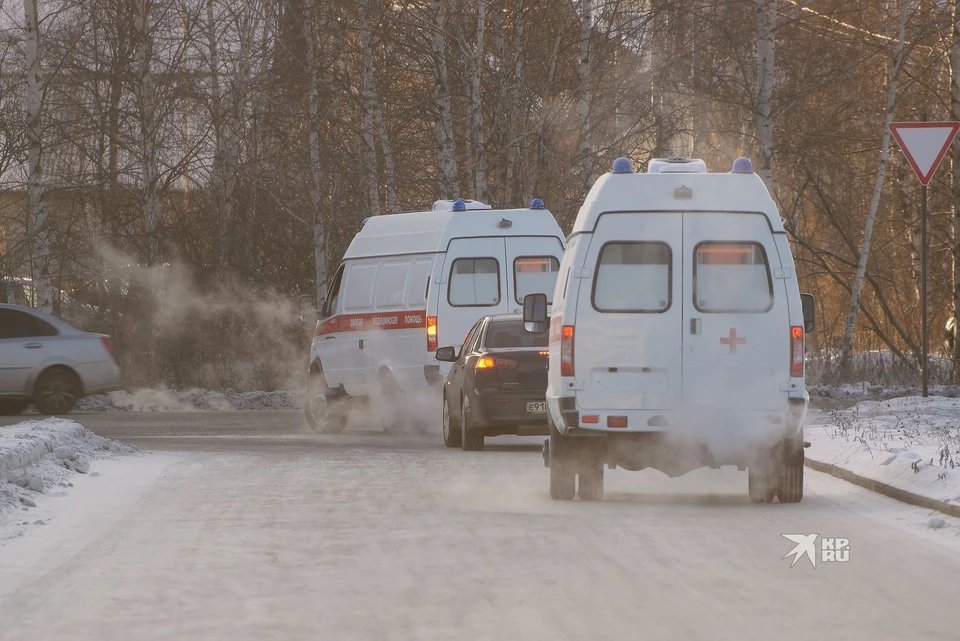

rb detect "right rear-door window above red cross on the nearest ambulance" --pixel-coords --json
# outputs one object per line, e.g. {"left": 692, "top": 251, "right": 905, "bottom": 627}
{"left": 693, "top": 243, "right": 773, "bottom": 314}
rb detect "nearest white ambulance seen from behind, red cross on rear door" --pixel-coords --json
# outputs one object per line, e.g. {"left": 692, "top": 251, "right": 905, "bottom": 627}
{"left": 524, "top": 158, "right": 814, "bottom": 503}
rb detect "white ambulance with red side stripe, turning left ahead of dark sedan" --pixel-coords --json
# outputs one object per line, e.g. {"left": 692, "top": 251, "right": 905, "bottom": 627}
{"left": 305, "top": 198, "right": 565, "bottom": 433}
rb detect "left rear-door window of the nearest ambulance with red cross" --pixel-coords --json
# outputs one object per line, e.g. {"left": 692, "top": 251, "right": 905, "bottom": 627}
{"left": 593, "top": 242, "right": 673, "bottom": 313}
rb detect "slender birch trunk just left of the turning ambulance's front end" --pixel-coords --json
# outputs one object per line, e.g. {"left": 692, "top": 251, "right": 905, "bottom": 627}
{"left": 302, "top": 0, "right": 328, "bottom": 303}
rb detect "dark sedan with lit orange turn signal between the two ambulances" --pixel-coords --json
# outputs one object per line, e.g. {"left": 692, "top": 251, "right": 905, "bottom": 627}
{"left": 437, "top": 315, "right": 549, "bottom": 451}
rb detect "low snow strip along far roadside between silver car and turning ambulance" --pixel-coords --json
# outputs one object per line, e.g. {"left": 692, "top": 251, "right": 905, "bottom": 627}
{"left": 68, "top": 389, "right": 303, "bottom": 412}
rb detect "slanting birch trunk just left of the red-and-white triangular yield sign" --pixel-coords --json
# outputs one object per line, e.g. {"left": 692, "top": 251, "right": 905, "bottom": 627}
{"left": 842, "top": 0, "right": 911, "bottom": 364}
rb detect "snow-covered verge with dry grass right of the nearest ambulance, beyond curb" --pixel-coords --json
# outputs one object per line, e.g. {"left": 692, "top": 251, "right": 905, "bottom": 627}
{"left": 804, "top": 396, "right": 960, "bottom": 506}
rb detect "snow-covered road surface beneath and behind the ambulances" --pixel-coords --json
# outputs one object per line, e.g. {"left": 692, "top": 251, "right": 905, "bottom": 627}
{"left": 0, "top": 412, "right": 960, "bottom": 641}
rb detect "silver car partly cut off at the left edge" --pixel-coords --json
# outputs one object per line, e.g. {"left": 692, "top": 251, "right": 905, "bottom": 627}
{"left": 0, "top": 305, "right": 120, "bottom": 415}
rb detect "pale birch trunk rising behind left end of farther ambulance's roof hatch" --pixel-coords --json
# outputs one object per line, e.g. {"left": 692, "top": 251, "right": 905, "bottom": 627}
{"left": 430, "top": 0, "right": 460, "bottom": 198}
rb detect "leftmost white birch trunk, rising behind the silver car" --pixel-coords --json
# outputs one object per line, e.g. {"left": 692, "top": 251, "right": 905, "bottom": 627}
{"left": 23, "top": 0, "right": 53, "bottom": 314}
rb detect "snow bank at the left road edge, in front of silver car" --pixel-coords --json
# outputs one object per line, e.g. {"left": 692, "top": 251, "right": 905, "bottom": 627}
{"left": 0, "top": 418, "right": 137, "bottom": 516}
